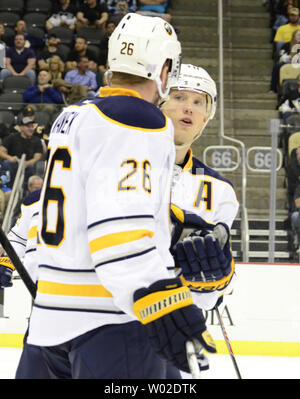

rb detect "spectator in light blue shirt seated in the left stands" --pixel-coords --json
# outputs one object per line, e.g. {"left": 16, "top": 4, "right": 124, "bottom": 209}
{"left": 64, "top": 56, "right": 97, "bottom": 96}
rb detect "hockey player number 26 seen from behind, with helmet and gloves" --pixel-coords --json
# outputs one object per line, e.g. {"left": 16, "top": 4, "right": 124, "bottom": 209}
{"left": 17, "top": 14, "right": 215, "bottom": 378}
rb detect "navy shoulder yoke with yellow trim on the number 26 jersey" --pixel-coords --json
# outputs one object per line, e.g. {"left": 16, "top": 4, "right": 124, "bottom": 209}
{"left": 76, "top": 95, "right": 167, "bottom": 131}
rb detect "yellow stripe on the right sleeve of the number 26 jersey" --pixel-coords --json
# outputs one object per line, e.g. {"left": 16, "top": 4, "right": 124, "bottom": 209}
{"left": 89, "top": 230, "right": 154, "bottom": 253}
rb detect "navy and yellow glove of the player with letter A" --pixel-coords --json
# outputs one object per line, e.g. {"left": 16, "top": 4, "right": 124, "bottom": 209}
{"left": 171, "top": 206, "right": 234, "bottom": 292}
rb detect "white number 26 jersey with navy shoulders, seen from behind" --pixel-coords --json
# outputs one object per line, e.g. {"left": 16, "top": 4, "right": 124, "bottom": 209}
{"left": 28, "top": 88, "right": 175, "bottom": 346}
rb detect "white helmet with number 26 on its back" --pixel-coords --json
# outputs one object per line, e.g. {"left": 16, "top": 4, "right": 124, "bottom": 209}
{"left": 108, "top": 13, "right": 181, "bottom": 98}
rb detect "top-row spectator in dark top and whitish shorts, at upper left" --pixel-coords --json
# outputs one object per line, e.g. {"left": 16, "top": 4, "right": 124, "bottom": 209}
{"left": 45, "top": 0, "right": 78, "bottom": 31}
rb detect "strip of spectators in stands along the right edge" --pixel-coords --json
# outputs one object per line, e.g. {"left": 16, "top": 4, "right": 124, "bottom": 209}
{"left": 264, "top": 0, "right": 300, "bottom": 253}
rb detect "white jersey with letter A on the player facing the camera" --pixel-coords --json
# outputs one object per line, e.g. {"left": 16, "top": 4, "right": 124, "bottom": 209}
{"left": 171, "top": 149, "right": 239, "bottom": 310}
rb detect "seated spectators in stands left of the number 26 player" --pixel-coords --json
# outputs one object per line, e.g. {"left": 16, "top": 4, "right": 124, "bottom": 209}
{"left": 0, "top": 0, "right": 172, "bottom": 219}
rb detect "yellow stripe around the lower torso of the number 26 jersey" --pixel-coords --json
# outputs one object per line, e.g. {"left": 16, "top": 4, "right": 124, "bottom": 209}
{"left": 37, "top": 280, "right": 112, "bottom": 298}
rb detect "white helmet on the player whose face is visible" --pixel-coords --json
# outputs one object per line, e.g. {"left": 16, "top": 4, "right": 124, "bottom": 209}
{"left": 171, "top": 64, "right": 217, "bottom": 119}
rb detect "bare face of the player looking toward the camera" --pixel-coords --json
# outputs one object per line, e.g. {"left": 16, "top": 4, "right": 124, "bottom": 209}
{"left": 162, "top": 89, "right": 211, "bottom": 145}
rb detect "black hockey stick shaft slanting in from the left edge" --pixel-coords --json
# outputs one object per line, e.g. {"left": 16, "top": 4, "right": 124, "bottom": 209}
{"left": 0, "top": 226, "right": 36, "bottom": 299}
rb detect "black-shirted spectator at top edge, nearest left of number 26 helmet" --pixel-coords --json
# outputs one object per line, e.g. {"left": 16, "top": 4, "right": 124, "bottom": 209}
{"left": 76, "top": 0, "right": 109, "bottom": 32}
